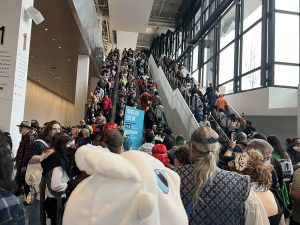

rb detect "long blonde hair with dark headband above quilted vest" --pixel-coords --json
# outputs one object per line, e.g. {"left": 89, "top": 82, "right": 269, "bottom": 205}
{"left": 190, "top": 127, "right": 220, "bottom": 206}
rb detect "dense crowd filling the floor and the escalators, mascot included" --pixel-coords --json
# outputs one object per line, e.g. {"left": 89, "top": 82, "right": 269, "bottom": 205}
{"left": 0, "top": 49, "right": 300, "bottom": 225}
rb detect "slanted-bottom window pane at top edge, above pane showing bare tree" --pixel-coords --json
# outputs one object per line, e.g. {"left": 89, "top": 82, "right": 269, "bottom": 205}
{"left": 243, "top": 0, "right": 262, "bottom": 31}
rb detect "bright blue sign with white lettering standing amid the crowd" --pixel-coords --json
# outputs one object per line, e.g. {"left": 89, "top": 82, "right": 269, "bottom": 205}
{"left": 124, "top": 105, "right": 145, "bottom": 150}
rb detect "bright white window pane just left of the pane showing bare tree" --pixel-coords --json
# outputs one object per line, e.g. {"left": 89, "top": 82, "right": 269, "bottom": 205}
{"left": 219, "top": 44, "right": 234, "bottom": 84}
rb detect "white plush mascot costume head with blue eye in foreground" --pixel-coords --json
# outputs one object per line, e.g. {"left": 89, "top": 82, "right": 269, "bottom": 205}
{"left": 63, "top": 145, "right": 188, "bottom": 225}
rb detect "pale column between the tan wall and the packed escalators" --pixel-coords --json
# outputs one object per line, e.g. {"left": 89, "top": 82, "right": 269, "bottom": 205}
{"left": 73, "top": 55, "right": 90, "bottom": 124}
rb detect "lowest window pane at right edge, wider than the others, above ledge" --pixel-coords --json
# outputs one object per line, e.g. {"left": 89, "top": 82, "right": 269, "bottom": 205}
{"left": 274, "top": 64, "right": 299, "bottom": 87}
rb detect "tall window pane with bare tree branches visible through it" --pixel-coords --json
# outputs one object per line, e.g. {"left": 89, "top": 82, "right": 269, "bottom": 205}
{"left": 242, "top": 23, "right": 261, "bottom": 73}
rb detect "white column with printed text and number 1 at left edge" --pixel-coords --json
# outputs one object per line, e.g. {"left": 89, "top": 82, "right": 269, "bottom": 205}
{"left": 0, "top": 0, "right": 33, "bottom": 153}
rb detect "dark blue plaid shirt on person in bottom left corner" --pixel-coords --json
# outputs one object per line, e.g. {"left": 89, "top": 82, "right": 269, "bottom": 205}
{"left": 0, "top": 189, "right": 25, "bottom": 225}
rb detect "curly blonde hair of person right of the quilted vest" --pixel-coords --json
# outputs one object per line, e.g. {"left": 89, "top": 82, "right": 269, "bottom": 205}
{"left": 228, "top": 149, "right": 273, "bottom": 190}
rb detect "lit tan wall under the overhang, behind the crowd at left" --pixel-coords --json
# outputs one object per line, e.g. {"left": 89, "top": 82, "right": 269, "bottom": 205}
{"left": 24, "top": 80, "right": 75, "bottom": 126}
